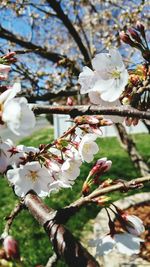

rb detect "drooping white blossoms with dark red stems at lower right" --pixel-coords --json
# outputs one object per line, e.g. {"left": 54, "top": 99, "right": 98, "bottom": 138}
{"left": 89, "top": 205, "right": 145, "bottom": 257}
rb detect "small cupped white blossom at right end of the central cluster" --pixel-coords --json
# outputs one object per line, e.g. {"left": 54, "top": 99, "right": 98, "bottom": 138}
{"left": 79, "top": 134, "right": 99, "bottom": 163}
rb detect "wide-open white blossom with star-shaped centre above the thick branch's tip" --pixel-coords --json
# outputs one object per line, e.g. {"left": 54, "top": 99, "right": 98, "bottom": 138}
{"left": 7, "top": 161, "right": 54, "bottom": 197}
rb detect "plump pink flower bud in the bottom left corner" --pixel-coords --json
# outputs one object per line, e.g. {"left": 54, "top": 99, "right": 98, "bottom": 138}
{"left": 3, "top": 235, "right": 20, "bottom": 259}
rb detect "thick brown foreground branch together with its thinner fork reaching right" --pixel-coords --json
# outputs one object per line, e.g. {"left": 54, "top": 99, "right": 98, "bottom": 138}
{"left": 24, "top": 175, "right": 150, "bottom": 267}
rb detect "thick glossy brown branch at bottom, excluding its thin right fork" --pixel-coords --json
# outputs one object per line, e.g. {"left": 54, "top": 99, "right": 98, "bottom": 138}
{"left": 25, "top": 193, "right": 99, "bottom": 267}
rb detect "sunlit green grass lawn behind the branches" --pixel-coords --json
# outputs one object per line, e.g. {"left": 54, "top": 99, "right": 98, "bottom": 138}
{"left": 0, "top": 128, "right": 150, "bottom": 267}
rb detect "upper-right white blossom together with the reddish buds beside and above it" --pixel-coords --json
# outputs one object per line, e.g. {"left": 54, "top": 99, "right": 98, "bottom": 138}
{"left": 78, "top": 22, "right": 150, "bottom": 125}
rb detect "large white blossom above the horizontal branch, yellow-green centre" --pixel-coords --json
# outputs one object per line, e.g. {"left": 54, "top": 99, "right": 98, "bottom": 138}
{"left": 78, "top": 48, "right": 128, "bottom": 104}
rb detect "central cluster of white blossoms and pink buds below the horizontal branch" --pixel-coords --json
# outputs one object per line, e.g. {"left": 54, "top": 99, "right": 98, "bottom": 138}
{"left": 0, "top": 116, "right": 111, "bottom": 197}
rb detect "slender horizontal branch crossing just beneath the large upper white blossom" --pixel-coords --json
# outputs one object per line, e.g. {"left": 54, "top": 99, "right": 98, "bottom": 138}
{"left": 32, "top": 104, "right": 150, "bottom": 120}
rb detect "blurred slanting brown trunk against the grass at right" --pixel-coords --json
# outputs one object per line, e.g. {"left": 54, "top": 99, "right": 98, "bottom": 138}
{"left": 116, "top": 123, "right": 150, "bottom": 176}
